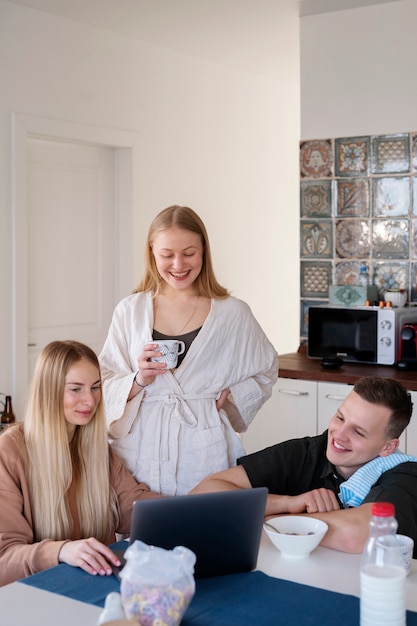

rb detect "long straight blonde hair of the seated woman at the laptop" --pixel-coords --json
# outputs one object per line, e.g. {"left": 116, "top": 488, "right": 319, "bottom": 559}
{"left": 23, "top": 341, "right": 118, "bottom": 541}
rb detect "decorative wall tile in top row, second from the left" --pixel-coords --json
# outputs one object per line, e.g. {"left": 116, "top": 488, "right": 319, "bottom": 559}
{"left": 335, "top": 137, "right": 370, "bottom": 176}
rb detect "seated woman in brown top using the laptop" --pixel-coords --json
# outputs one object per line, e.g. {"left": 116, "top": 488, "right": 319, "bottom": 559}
{"left": 0, "top": 341, "right": 159, "bottom": 585}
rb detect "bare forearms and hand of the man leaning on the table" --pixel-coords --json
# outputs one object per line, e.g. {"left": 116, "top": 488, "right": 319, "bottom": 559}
{"left": 190, "top": 465, "right": 372, "bottom": 553}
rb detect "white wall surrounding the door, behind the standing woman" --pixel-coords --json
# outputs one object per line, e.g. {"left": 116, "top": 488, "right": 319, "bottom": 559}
{"left": 0, "top": 0, "right": 299, "bottom": 404}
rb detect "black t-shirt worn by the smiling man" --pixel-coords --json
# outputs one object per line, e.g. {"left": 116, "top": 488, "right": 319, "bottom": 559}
{"left": 237, "top": 430, "right": 417, "bottom": 558}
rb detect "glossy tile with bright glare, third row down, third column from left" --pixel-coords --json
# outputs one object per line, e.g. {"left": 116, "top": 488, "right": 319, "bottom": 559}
{"left": 372, "top": 220, "right": 408, "bottom": 259}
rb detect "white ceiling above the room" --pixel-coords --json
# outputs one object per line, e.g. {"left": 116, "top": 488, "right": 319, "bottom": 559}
{"left": 3, "top": 0, "right": 399, "bottom": 76}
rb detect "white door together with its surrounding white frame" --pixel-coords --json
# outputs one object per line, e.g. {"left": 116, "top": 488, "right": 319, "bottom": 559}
{"left": 11, "top": 113, "right": 139, "bottom": 419}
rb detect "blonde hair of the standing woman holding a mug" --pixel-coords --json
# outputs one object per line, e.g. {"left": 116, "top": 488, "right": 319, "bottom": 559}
{"left": 133, "top": 204, "right": 230, "bottom": 299}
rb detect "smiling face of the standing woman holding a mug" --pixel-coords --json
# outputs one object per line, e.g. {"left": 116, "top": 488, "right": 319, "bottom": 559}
{"left": 152, "top": 227, "right": 203, "bottom": 289}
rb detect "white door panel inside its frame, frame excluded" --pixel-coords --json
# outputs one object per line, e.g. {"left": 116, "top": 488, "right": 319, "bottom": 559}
{"left": 27, "top": 138, "right": 117, "bottom": 380}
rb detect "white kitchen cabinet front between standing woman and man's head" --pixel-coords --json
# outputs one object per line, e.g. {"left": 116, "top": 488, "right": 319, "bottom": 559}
{"left": 241, "top": 378, "right": 317, "bottom": 454}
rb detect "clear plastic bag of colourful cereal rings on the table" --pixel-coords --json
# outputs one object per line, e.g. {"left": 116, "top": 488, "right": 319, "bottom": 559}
{"left": 120, "top": 541, "right": 196, "bottom": 626}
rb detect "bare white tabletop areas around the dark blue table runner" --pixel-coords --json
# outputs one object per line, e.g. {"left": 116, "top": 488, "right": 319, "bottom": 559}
{"left": 0, "top": 534, "right": 417, "bottom": 626}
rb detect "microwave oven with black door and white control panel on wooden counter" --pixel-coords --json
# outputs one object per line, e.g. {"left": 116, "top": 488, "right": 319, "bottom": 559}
{"left": 307, "top": 306, "right": 417, "bottom": 367}
